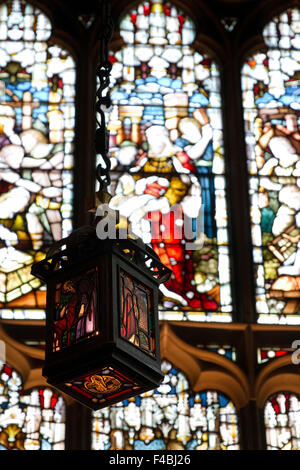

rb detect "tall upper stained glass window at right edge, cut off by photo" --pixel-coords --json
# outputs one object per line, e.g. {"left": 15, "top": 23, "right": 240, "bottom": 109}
{"left": 242, "top": 9, "right": 300, "bottom": 324}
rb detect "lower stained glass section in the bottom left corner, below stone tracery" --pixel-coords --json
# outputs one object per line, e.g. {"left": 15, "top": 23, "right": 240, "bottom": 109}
{"left": 0, "top": 363, "right": 65, "bottom": 450}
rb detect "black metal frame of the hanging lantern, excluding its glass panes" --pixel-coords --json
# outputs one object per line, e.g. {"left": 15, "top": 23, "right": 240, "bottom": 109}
{"left": 32, "top": 227, "right": 171, "bottom": 410}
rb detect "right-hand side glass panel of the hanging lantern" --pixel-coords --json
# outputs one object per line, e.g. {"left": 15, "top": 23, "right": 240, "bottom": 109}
{"left": 120, "top": 270, "right": 155, "bottom": 356}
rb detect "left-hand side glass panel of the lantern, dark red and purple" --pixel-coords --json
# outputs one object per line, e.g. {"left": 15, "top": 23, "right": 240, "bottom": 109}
{"left": 53, "top": 268, "right": 98, "bottom": 351}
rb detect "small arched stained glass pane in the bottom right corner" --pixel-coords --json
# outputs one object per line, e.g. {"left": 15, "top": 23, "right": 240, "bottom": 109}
{"left": 264, "top": 392, "right": 300, "bottom": 450}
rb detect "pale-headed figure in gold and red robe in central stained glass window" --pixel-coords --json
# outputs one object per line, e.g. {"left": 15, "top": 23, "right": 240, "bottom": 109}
{"left": 111, "top": 110, "right": 218, "bottom": 310}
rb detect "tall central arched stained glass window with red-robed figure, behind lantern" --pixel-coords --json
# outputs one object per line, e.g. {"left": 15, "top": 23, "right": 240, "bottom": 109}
{"left": 108, "top": 0, "right": 232, "bottom": 322}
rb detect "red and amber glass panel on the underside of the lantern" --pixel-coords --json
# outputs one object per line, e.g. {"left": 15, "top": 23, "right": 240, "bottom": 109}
{"left": 64, "top": 367, "right": 139, "bottom": 404}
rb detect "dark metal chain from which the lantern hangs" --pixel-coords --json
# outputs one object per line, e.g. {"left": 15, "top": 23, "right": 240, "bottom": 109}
{"left": 95, "top": 0, "right": 113, "bottom": 191}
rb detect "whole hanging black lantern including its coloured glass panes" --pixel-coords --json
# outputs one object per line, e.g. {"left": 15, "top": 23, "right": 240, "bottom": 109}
{"left": 32, "top": 227, "right": 170, "bottom": 410}
